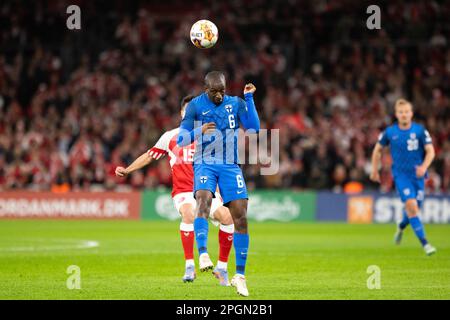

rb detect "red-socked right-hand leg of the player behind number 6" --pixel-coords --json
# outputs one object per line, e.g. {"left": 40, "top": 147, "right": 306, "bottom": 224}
{"left": 213, "top": 206, "right": 234, "bottom": 286}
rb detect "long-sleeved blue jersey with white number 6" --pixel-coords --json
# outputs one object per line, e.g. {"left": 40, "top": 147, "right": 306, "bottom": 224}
{"left": 177, "top": 93, "right": 259, "bottom": 164}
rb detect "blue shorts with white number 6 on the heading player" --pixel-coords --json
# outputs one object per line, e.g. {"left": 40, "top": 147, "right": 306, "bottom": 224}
{"left": 194, "top": 164, "right": 248, "bottom": 204}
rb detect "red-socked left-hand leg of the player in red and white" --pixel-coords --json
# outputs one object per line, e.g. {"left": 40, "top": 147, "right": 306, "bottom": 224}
{"left": 180, "top": 203, "right": 196, "bottom": 282}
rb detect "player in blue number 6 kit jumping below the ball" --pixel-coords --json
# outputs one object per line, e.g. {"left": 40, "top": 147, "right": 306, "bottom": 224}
{"left": 177, "top": 71, "right": 260, "bottom": 296}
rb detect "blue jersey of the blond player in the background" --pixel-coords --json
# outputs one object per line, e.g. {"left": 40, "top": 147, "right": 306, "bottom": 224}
{"left": 378, "top": 122, "right": 432, "bottom": 178}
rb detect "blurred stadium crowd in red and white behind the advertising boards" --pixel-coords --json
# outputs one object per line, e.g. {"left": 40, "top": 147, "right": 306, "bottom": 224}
{"left": 0, "top": 0, "right": 450, "bottom": 192}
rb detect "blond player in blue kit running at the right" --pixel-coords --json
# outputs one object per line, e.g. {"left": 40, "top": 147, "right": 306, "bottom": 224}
{"left": 370, "top": 99, "right": 436, "bottom": 255}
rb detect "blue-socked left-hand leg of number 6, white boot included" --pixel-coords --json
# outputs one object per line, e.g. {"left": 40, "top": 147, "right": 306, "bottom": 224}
{"left": 194, "top": 190, "right": 214, "bottom": 272}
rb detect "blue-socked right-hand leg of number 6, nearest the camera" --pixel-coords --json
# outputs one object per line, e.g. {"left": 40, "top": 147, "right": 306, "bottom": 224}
{"left": 228, "top": 199, "right": 249, "bottom": 297}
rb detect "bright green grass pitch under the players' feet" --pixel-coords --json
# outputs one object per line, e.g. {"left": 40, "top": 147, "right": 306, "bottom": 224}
{"left": 0, "top": 220, "right": 450, "bottom": 300}
